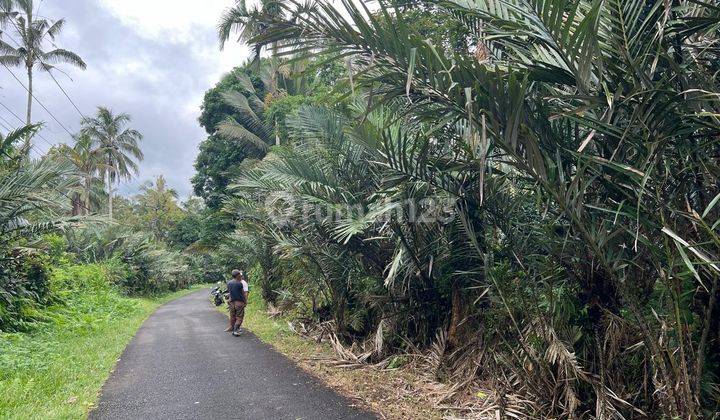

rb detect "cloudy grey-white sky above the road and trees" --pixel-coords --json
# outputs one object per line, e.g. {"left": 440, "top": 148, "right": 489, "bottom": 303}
{"left": 0, "top": 0, "right": 248, "bottom": 197}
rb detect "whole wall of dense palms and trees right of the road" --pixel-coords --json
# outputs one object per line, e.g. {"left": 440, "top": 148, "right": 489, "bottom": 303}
{"left": 194, "top": 0, "right": 720, "bottom": 418}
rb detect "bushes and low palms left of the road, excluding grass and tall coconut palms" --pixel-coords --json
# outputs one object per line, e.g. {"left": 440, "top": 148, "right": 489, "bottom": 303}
{"left": 0, "top": 108, "right": 198, "bottom": 331}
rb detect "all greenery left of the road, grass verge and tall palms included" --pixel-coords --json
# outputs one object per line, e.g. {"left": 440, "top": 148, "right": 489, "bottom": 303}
{"left": 0, "top": 0, "right": 211, "bottom": 419}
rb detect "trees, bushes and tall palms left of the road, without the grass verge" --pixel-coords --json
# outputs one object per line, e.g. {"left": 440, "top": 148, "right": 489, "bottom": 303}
{"left": 0, "top": 0, "right": 202, "bottom": 332}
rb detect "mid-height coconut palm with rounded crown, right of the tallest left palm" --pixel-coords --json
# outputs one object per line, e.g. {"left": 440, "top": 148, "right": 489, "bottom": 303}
{"left": 80, "top": 107, "right": 143, "bottom": 219}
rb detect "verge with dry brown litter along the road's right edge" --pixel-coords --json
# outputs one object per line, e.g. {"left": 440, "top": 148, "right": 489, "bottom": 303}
{"left": 233, "top": 299, "right": 443, "bottom": 419}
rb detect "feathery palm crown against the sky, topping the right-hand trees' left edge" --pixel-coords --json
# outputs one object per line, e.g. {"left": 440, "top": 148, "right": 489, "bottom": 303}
{"left": 218, "top": 0, "right": 283, "bottom": 61}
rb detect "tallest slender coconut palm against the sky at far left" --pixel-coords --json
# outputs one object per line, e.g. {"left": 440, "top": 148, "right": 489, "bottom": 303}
{"left": 0, "top": 0, "right": 86, "bottom": 131}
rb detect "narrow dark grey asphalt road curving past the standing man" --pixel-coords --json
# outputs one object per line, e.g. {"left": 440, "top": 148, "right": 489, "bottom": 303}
{"left": 90, "top": 290, "right": 375, "bottom": 420}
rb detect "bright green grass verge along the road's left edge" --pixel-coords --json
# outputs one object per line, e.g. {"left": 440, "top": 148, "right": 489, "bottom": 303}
{"left": 0, "top": 287, "right": 204, "bottom": 419}
